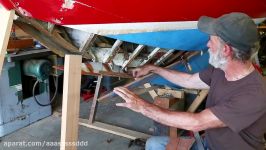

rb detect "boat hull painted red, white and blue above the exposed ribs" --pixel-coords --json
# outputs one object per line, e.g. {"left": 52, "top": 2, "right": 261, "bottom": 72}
{"left": 0, "top": 0, "right": 266, "bottom": 50}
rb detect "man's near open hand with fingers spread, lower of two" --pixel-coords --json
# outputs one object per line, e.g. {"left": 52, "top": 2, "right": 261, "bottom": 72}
{"left": 114, "top": 87, "right": 148, "bottom": 112}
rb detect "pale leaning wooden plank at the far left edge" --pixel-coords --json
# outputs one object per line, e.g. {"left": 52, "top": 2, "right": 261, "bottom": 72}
{"left": 0, "top": 7, "right": 15, "bottom": 75}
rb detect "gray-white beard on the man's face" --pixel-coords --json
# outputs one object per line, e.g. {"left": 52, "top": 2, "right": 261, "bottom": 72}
{"left": 208, "top": 49, "right": 227, "bottom": 70}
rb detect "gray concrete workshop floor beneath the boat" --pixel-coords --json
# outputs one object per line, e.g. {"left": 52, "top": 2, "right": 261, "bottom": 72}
{"left": 0, "top": 94, "right": 153, "bottom": 150}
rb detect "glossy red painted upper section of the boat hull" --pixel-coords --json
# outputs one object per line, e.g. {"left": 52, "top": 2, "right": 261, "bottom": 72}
{"left": 0, "top": 0, "right": 266, "bottom": 25}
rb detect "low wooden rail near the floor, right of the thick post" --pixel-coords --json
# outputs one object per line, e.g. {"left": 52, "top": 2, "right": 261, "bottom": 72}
{"left": 79, "top": 119, "right": 150, "bottom": 140}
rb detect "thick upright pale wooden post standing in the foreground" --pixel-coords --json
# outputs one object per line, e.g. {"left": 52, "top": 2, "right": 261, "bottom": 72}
{"left": 60, "top": 55, "right": 82, "bottom": 150}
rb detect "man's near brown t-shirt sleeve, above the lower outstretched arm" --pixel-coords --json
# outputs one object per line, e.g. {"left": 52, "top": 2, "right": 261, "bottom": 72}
{"left": 209, "top": 88, "right": 266, "bottom": 132}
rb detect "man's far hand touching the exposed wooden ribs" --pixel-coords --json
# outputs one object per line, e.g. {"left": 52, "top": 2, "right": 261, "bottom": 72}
{"left": 130, "top": 65, "right": 156, "bottom": 78}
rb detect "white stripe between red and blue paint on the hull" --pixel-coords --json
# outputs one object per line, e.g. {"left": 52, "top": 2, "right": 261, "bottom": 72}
{"left": 64, "top": 18, "right": 266, "bottom": 35}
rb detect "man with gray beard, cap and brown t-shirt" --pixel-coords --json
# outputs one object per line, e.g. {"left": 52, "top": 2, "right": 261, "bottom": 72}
{"left": 114, "top": 13, "right": 266, "bottom": 150}
